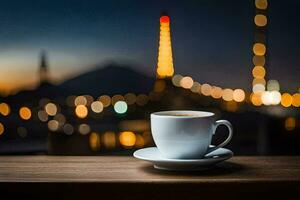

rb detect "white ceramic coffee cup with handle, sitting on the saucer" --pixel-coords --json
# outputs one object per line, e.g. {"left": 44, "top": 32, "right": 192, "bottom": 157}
{"left": 151, "top": 110, "right": 233, "bottom": 159}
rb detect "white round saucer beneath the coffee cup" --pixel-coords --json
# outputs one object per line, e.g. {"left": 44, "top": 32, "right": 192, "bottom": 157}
{"left": 133, "top": 147, "right": 233, "bottom": 171}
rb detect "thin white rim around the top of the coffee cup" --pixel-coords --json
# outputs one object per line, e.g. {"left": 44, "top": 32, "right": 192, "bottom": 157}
{"left": 151, "top": 110, "right": 215, "bottom": 119}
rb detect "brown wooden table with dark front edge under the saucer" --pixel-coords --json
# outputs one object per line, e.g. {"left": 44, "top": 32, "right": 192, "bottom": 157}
{"left": 0, "top": 156, "right": 300, "bottom": 200}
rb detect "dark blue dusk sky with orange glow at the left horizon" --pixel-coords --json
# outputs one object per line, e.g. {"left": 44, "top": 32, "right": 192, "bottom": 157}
{"left": 0, "top": 0, "right": 300, "bottom": 92}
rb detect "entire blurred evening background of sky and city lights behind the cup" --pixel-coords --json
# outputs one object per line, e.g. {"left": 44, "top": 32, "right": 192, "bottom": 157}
{"left": 0, "top": 0, "right": 300, "bottom": 155}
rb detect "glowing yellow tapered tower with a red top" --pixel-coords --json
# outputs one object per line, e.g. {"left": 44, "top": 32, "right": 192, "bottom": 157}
{"left": 156, "top": 15, "right": 174, "bottom": 79}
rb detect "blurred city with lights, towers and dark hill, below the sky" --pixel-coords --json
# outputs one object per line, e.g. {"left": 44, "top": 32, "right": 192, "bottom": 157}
{"left": 0, "top": 0, "right": 300, "bottom": 155}
